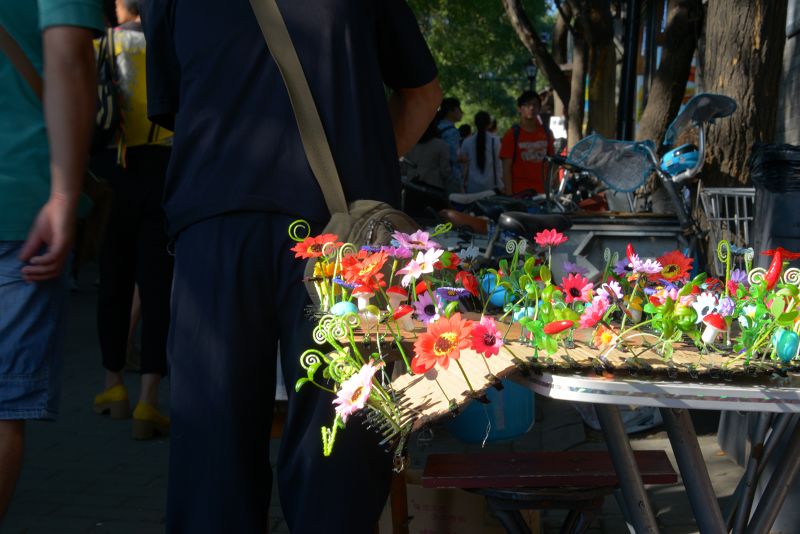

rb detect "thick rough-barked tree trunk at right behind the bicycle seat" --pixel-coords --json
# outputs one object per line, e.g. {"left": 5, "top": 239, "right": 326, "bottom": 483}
{"left": 703, "top": 0, "right": 787, "bottom": 186}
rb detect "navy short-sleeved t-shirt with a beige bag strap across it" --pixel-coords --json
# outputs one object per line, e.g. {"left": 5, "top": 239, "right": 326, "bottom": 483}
{"left": 143, "top": 0, "right": 436, "bottom": 234}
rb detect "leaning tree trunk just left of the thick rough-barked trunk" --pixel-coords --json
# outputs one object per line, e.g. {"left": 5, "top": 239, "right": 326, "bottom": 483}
{"left": 636, "top": 0, "right": 703, "bottom": 145}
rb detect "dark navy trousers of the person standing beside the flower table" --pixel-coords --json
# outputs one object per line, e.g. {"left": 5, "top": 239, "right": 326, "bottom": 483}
{"left": 167, "top": 213, "right": 391, "bottom": 534}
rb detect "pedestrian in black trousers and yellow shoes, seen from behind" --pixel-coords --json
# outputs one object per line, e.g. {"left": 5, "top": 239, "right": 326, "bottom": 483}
{"left": 92, "top": 0, "right": 172, "bottom": 439}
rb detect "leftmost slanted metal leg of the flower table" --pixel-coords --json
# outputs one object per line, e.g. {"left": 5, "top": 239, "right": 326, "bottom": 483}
{"left": 595, "top": 404, "right": 658, "bottom": 534}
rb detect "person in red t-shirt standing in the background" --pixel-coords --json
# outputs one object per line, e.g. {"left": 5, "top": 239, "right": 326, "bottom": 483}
{"left": 500, "top": 91, "right": 553, "bottom": 195}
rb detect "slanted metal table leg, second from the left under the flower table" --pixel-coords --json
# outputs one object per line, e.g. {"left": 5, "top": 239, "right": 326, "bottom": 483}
{"left": 660, "top": 408, "right": 728, "bottom": 534}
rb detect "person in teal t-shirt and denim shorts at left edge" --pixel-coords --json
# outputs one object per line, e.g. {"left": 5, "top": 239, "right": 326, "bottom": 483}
{"left": 0, "top": 0, "right": 103, "bottom": 521}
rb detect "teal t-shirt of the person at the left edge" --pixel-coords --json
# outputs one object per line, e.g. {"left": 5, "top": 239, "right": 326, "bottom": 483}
{"left": 0, "top": 0, "right": 104, "bottom": 241}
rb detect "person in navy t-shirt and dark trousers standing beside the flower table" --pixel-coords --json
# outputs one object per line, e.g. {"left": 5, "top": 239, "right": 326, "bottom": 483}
{"left": 143, "top": 0, "right": 441, "bottom": 534}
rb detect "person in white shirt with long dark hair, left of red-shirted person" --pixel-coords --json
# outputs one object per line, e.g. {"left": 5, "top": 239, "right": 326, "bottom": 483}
{"left": 461, "top": 111, "right": 503, "bottom": 193}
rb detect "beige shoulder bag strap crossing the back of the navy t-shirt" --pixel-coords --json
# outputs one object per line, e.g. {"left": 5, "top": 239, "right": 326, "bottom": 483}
{"left": 250, "top": 0, "right": 347, "bottom": 215}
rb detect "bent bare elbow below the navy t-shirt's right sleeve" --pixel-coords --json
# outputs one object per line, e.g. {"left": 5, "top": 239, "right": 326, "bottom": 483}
{"left": 389, "top": 79, "right": 442, "bottom": 156}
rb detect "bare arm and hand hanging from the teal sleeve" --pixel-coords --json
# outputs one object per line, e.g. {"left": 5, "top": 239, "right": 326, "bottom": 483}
{"left": 20, "top": 26, "right": 97, "bottom": 282}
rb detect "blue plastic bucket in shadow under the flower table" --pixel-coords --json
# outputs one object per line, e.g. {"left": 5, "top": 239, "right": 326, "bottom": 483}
{"left": 447, "top": 380, "right": 535, "bottom": 443}
